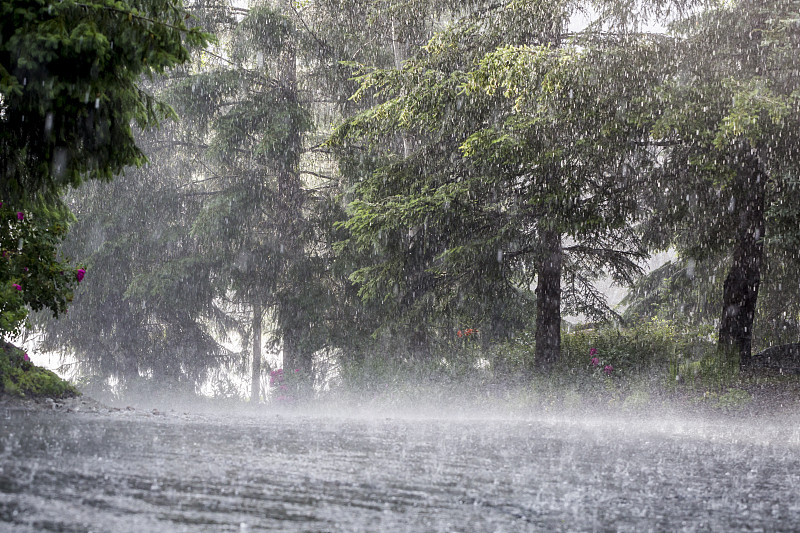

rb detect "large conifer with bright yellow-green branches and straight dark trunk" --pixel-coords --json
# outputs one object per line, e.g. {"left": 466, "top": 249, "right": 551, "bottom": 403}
{"left": 333, "top": 2, "right": 655, "bottom": 371}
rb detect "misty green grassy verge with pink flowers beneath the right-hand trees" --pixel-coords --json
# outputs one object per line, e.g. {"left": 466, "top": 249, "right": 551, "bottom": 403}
{"left": 318, "top": 320, "right": 800, "bottom": 415}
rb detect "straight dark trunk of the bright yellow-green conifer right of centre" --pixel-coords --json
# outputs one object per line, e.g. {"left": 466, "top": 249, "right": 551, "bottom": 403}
{"left": 535, "top": 230, "right": 562, "bottom": 374}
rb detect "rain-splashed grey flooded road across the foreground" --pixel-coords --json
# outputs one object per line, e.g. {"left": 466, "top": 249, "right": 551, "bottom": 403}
{"left": 0, "top": 409, "right": 800, "bottom": 533}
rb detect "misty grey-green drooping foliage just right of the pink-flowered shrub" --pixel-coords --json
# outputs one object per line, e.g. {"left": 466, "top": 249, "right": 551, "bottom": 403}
{"left": 35, "top": 154, "right": 234, "bottom": 391}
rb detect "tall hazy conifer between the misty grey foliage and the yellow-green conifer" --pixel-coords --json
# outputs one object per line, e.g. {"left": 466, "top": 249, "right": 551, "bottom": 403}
{"left": 164, "top": 1, "right": 424, "bottom": 398}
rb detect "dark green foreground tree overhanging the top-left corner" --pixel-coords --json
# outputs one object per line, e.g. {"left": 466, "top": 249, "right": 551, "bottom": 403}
{"left": 0, "top": 0, "right": 209, "bottom": 334}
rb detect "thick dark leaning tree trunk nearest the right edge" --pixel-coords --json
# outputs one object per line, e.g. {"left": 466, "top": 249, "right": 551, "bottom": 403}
{"left": 717, "top": 155, "right": 767, "bottom": 370}
